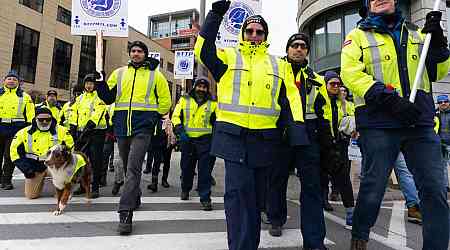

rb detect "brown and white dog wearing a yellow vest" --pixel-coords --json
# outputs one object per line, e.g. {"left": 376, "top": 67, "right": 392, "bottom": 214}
{"left": 44, "top": 145, "right": 92, "bottom": 215}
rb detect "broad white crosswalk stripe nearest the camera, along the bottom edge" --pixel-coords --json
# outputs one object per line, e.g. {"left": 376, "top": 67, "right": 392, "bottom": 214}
{"left": 0, "top": 229, "right": 335, "bottom": 250}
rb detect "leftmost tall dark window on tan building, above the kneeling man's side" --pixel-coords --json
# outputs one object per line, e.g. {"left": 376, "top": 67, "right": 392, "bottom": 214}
{"left": 11, "top": 24, "right": 39, "bottom": 83}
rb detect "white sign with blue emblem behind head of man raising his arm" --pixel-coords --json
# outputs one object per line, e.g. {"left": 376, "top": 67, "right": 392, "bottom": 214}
{"left": 216, "top": 0, "right": 262, "bottom": 48}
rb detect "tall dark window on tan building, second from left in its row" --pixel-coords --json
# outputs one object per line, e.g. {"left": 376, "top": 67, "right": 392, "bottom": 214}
{"left": 50, "top": 38, "right": 72, "bottom": 89}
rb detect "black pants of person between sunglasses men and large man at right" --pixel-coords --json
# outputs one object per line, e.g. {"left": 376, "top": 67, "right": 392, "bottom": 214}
{"left": 320, "top": 140, "right": 355, "bottom": 208}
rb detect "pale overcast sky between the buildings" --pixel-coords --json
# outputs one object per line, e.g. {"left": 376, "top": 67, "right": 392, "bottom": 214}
{"left": 128, "top": 0, "right": 298, "bottom": 55}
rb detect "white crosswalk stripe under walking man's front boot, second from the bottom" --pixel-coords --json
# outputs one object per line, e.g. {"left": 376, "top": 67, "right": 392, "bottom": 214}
{"left": 0, "top": 210, "right": 225, "bottom": 225}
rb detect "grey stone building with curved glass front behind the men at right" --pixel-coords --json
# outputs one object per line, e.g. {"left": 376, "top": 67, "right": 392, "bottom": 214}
{"left": 297, "top": 0, "right": 450, "bottom": 95}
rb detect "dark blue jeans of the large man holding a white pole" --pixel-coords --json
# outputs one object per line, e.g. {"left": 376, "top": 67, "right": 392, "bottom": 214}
{"left": 352, "top": 127, "right": 449, "bottom": 250}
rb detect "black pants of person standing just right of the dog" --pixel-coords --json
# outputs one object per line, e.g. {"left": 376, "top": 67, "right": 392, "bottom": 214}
{"left": 86, "top": 129, "right": 105, "bottom": 191}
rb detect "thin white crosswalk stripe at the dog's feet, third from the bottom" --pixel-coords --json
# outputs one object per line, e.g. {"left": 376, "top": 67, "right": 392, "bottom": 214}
{"left": 0, "top": 197, "right": 224, "bottom": 206}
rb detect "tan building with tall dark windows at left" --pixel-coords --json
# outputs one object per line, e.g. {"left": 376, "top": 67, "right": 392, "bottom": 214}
{"left": 0, "top": 0, "right": 181, "bottom": 101}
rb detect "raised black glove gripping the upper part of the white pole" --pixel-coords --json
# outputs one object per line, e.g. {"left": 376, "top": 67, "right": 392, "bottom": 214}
{"left": 422, "top": 11, "right": 447, "bottom": 48}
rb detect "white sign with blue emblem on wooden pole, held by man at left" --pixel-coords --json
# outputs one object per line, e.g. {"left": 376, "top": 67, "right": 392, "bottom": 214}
{"left": 71, "top": 0, "right": 128, "bottom": 37}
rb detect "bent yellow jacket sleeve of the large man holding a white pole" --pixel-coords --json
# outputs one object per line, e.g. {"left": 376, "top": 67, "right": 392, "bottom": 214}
{"left": 341, "top": 29, "right": 375, "bottom": 97}
